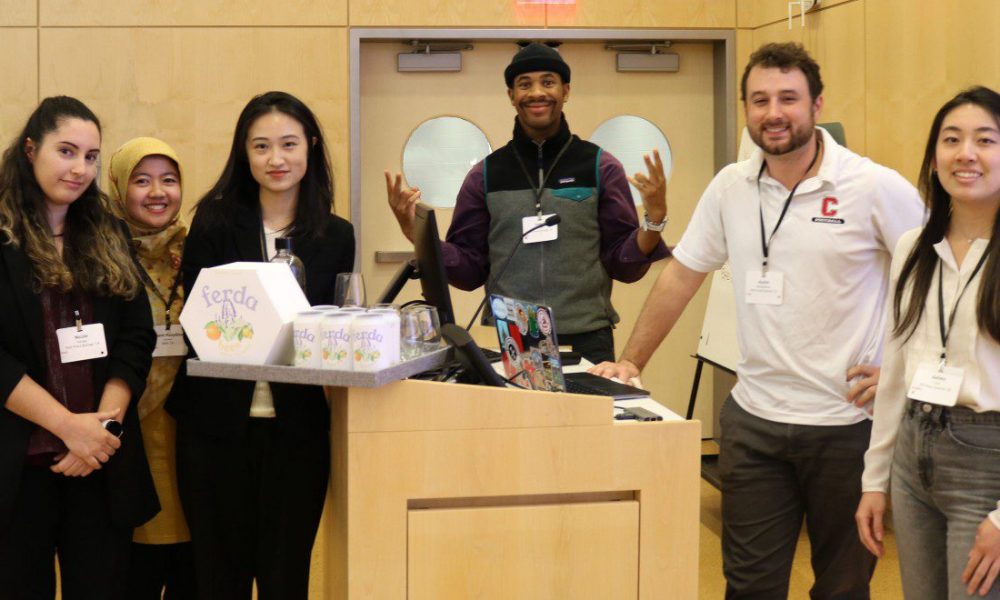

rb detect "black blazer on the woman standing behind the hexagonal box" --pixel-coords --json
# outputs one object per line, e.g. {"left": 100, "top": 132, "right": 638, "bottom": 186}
{"left": 167, "top": 206, "right": 354, "bottom": 438}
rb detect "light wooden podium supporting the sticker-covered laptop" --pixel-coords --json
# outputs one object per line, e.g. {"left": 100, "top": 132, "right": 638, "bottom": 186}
{"left": 320, "top": 380, "right": 700, "bottom": 599}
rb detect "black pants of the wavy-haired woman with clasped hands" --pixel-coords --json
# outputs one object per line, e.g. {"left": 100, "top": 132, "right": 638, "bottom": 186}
{"left": 0, "top": 466, "right": 132, "bottom": 600}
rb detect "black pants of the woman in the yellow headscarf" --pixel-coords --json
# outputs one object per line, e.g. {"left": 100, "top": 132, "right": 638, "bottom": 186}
{"left": 128, "top": 542, "right": 196, "bottom": 600}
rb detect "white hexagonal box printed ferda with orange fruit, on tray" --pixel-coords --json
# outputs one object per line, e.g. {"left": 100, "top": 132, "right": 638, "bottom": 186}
{"left": 180, "top": 262, "right": 309, "bottom": 365}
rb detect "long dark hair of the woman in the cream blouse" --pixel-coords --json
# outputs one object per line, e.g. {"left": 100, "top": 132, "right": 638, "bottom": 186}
{"left": 892, "top": 86, "right": 1000, "bottom": 342}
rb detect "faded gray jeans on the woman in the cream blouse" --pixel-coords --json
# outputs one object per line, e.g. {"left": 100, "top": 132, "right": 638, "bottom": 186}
{"left": 892, "top": 401, "right": 1000, "bottom": 600}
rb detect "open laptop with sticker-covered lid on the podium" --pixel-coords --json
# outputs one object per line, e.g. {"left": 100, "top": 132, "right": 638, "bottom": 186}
{"left": 490, "top": 294, "right": 649, "bottom": 400}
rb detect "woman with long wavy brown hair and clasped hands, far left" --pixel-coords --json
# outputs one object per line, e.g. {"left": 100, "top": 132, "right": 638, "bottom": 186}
{"left": 0, "top": 96, "right": 159, "bottom": 600}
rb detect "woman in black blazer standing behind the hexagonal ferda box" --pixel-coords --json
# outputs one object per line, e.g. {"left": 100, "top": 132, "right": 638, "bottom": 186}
{"left": 168, "top": 92, "right": 354, "bottom": 600}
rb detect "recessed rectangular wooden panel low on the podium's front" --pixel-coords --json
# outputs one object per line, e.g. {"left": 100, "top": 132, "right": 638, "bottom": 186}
{"left": 407, "top": 500, "right": 639, "bottom": 600}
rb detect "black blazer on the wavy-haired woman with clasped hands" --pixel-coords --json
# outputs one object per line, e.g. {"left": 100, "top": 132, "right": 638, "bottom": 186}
{"left": 0, "top": 236, "right": 160, "bottom": 528}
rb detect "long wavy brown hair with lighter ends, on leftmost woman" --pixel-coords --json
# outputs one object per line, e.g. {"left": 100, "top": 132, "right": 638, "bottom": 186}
{"left": 0, "top": 96, "right": 141, "bottom": 298}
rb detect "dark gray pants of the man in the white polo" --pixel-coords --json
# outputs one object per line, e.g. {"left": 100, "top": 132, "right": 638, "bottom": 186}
{"left": 719, "top": 396, "right": 875, "bottom": 600}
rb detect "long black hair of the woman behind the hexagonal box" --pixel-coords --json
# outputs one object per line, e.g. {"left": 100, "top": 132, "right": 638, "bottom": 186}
{"left": 197, "top": 92, "right": 333, "bottom": 238}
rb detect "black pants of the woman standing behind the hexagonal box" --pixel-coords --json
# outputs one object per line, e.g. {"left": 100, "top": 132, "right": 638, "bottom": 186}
{"left": 177, "top": 418, "right": 330, "bottom": 600}
